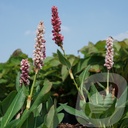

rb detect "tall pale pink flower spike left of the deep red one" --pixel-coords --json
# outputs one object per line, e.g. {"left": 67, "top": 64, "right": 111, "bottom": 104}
{"left": 33, "top": 22, "right": 46, "bottom": 70}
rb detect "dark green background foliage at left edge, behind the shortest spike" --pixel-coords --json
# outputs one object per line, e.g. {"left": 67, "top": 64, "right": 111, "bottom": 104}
{"left": 0, "top": 49, "right": 32, "bottom": 100}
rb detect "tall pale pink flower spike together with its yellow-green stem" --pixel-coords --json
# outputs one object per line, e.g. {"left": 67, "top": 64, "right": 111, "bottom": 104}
{"left": 26, "top": 22, "right": 46, "bottom": 109}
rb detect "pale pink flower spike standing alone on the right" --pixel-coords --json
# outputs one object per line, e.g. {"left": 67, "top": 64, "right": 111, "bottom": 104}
{"left": 104, "top": 37, "right": 114, "bottom": 70}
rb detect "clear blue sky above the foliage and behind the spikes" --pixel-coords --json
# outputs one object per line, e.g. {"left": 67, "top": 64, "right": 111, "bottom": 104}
{"left": 0, "top": 0, "right": 128, "bottom": 62}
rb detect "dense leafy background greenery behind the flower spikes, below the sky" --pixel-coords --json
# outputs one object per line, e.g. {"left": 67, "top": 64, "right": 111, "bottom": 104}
{"left": 0, "top": 39, "right": 128, "bottom": 127}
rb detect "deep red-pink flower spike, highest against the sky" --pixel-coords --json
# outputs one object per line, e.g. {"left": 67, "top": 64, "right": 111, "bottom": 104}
{"left": 51, "top": 6, "right": 64, "bottom": 47}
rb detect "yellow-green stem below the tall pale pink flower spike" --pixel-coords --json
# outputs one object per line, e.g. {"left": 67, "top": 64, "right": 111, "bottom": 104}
{"left": 26, "top": 70, "right": 38, "bottom": 109}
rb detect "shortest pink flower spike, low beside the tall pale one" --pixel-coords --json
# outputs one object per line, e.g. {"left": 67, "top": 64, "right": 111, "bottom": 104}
{"left": 20, "top": 59, "right": 30, "bottom": 86}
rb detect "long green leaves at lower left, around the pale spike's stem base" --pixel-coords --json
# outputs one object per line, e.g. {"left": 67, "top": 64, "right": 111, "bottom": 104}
{"left": 0, "top": 80, "right": 64, "bottom": 128}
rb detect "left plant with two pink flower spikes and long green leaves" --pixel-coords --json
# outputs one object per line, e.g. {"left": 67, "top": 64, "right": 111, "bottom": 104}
{"left": 0, "top": 22, "right": 63, "bottom": 128}
